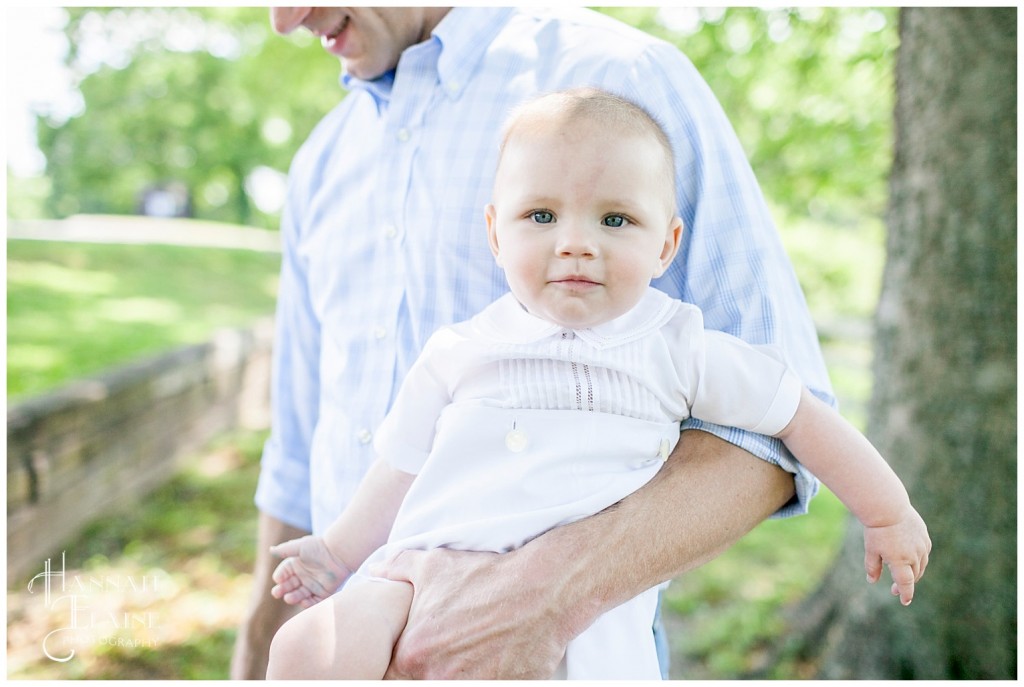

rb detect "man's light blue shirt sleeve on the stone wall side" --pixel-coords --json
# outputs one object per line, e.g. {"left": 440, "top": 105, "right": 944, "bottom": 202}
{"left": 256, "top": 158, "right": 321, "bottom": 531}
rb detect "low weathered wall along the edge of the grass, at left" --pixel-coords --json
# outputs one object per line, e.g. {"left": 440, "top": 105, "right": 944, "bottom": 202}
{"left": 7, "top": 319, "right": 273, "bottom": 584}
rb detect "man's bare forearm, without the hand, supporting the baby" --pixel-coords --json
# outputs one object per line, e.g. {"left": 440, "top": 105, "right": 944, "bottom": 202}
{"left": 521, "top": 431, "right": 794, "bottom": 636}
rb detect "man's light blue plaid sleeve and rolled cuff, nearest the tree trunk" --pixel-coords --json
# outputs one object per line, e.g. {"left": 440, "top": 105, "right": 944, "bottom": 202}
{"left": 622, "top": 42, "right": 836, "bottom": 515}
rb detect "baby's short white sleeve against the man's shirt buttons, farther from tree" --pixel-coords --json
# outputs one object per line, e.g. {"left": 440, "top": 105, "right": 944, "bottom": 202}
{"left": 374, "top": 329, "right": 452, "bottom": 475}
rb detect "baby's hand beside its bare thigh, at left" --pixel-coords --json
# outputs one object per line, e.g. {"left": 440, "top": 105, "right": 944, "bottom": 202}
{"left": 270, "top": 535, "right": 352, "bottom": 608}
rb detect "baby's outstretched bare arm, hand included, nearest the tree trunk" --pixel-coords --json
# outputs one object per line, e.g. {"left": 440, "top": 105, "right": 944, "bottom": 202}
{"left": 776, "top": 389, "right": 932, "bottom": 605}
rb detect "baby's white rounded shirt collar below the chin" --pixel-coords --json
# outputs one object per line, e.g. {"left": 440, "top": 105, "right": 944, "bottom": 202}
{"left": 474, "top": 289, "right": 680, "bottom": 349}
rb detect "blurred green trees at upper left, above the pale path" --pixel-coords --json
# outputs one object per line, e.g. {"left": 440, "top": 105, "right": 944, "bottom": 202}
{"left": 38, "top": 7, "right": 342, "bottom": 227}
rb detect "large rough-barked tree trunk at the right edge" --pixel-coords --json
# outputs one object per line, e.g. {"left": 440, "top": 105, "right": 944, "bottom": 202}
{"left": 796, "top": 7, "right": 1017, "bottom": 680}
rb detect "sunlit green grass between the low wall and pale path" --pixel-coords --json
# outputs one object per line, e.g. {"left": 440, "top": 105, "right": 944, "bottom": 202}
{"left": 7, "top": 241, "right": 281, "bottom": 400}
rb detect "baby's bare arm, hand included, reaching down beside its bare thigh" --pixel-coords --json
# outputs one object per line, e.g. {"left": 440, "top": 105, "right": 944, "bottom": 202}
{"left": 270, "top": 460, "right": 416, "bottom": 608}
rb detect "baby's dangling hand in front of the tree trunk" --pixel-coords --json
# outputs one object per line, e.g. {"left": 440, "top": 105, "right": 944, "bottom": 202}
{"left": 864, "top": 506, "right": 932, "bottom": 606}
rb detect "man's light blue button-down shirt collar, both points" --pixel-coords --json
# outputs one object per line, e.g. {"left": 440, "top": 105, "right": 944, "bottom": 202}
{"left": 341, "top": 7, "right": 515, "bottom": 112}
